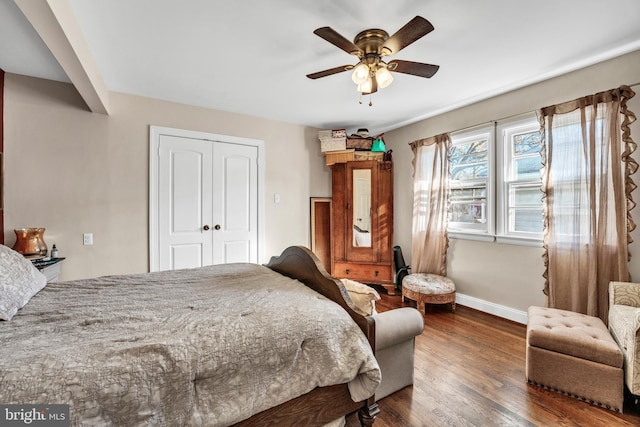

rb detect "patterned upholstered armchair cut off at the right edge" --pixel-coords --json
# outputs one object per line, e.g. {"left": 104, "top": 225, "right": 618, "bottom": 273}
{"left": 609, "top": 282, "right": 640, "bottom": 396}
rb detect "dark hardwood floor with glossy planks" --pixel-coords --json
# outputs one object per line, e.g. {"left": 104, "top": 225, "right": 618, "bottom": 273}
{"left": 347, "top": 291, "right": 640, "bottom": 427}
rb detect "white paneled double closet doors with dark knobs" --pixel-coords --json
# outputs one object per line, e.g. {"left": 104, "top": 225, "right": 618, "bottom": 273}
{"left": 150, "top": 129, "right": 260, "bottom": 271}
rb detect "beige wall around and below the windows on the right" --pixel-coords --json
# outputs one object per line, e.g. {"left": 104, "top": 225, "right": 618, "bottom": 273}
{"left": 385, "top": 51, "right": 640, "bottom": 311}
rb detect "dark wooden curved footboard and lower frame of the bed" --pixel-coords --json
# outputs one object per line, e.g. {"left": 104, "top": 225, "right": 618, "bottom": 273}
{"left": 236, "top": 246, "right": 380, "bottom": 426}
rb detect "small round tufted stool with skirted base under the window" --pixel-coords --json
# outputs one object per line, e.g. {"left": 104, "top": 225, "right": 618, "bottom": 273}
{"left": 402, "top": 273, "right": 456, "bottom": 314}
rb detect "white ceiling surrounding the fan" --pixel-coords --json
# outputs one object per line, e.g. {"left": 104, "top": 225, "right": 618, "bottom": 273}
{"left": 0, "top": 0, "right": 640, "bottom": 134}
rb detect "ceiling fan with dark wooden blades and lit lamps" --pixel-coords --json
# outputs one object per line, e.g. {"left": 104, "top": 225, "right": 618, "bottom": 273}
{"left": 307, "top": 16, "right": 440, "bottom": 98}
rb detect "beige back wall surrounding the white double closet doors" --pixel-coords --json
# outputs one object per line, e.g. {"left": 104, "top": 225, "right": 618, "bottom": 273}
{"left": 4, "top": 74, "right": 331, "bottom": 280}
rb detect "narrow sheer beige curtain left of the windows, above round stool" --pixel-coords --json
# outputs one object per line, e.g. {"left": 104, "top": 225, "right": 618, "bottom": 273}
{"left": 410, "top": 134, "right": 451, "bottom": 276}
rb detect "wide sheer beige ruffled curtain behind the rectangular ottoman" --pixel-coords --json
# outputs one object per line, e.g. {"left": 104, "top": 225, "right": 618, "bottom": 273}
{"left": 540, "top": 86, "right": 638, "bottom": 322}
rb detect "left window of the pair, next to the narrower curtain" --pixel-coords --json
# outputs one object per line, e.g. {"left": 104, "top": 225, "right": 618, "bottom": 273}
{"left": 448, "top": 127, "right": 494, "bottom": 236}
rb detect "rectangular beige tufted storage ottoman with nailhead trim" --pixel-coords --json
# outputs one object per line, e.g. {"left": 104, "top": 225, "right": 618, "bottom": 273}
{"left": 526, "top": 307, "right": 624, "bottom": 412}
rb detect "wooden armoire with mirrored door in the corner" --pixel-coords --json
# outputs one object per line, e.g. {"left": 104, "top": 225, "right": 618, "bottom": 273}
{"left": 331, "top": 160, "right": 395, "bottom": 295}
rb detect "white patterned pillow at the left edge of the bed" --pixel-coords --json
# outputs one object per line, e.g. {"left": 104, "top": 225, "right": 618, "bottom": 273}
{"left": 0, "top": 245, "right": 47, "bottom": 320}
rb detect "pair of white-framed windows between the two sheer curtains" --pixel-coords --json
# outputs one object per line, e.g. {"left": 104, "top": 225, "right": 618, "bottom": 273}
{"left": 448, "top": 115, "right": 543, "bottom": 243}
